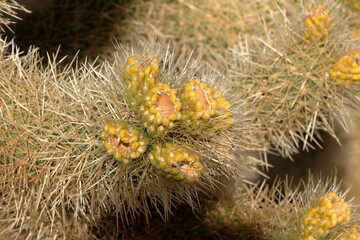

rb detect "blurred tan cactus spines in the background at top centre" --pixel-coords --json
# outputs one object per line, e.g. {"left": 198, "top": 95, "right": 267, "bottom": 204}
{"left": 119, "top": 0, "right": 294, "bottom": 70}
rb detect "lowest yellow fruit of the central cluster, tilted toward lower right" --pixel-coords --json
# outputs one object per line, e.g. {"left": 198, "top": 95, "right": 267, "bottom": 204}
{"left": 149, "top": 142, "right": 203, "bottom": 183}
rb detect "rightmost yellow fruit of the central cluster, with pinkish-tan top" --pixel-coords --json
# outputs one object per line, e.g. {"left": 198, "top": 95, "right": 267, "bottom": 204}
{"left": 180, "top": 79, "right": 232, "bottom": 135}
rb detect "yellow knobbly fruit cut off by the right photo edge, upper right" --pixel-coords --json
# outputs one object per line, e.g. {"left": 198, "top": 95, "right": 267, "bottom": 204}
{"left": 329, "top": 51, "right": 360, "bottom": 84}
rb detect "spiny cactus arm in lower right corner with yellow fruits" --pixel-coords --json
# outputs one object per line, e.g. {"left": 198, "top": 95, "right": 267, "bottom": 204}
{"left": 205, "top": 176, "right": 360, "bottom": 240}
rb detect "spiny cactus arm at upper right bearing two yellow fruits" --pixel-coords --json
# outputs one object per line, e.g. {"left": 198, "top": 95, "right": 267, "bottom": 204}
{"left": 229, "top": 3, "right": 360, "bottom": 156}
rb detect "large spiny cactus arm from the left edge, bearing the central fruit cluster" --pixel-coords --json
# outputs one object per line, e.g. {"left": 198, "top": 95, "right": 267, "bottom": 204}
{"left": 0, "top": 37, "right": 258, "bottom": 237}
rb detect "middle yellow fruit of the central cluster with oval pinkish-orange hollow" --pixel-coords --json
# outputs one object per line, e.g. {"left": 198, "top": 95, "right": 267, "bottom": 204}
{"left": 139, "top": 83, "right": 181, "bottom": 135}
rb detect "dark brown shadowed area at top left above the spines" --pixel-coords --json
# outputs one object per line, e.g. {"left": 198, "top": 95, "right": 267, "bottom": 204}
{"left": 5, "top": 0, "right": 128, "bottom": 63}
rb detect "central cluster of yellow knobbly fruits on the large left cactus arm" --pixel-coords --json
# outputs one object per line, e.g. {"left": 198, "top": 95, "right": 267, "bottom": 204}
{"left": 101, "top": 55, "right": 233, "bottom": 183}
